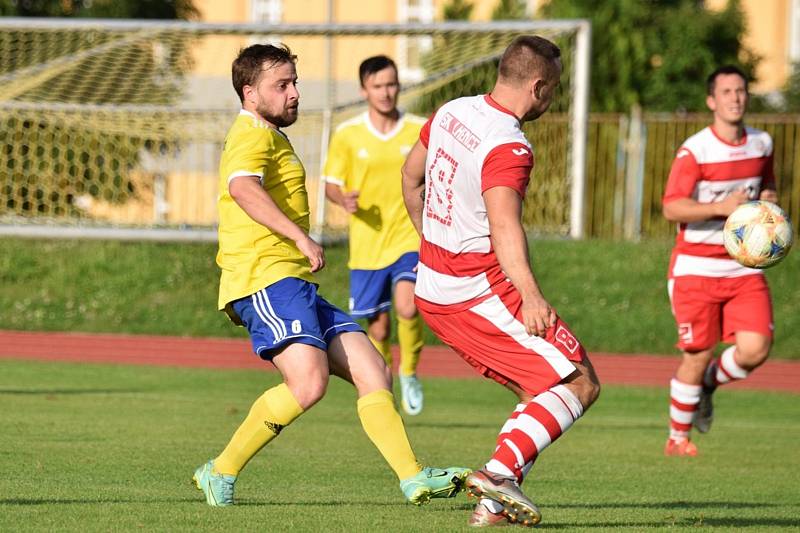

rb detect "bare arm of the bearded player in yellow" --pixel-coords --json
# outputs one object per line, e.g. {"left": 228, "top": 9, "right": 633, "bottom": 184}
{"left": 228, "top": 176, "right": 325, "bottom": 272}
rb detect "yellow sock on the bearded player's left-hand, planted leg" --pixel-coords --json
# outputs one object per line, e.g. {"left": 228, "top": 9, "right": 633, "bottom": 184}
{"left": 214, "top": 383, "right": 303, "bottom": 476}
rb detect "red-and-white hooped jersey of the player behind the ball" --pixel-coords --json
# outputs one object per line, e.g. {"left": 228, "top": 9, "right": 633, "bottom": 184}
{"left": 663, "top": 126, "right": 775, "bottom": 278}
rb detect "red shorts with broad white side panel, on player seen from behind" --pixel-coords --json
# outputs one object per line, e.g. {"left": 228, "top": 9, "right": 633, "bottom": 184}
{"left": 417, "top": 282, "right": 586, "bottom": 395}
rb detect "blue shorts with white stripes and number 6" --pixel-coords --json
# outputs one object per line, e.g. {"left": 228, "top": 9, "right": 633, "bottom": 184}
{"left": 232, "top": 278, "right": 364, "bottom": 361}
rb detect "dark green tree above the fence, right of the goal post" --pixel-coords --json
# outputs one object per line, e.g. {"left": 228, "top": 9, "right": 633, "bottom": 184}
{"left": 541, "top": 0, "right": 758, "bottom": 112}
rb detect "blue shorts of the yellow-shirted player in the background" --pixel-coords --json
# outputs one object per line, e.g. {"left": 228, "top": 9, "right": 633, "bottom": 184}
{"left": 350, "top": 252, "right": 419, "bottom": 318}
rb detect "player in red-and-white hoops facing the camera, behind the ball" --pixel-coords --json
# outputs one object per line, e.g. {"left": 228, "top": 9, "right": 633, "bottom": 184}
{"left": 663, "top": 66, "right": 777, "bottom": 456}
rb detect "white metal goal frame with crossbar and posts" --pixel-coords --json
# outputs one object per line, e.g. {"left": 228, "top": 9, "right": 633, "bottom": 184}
{"left": 0, "top": 17, "right": 591, "bottom": 241}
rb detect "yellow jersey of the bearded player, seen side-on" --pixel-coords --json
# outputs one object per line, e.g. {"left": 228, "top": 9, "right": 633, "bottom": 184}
{"left": 217, "top": 110, "right": 314, "bottom": 324}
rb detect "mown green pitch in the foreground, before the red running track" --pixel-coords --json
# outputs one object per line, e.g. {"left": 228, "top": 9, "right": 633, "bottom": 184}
{"left": 0, "top": 360, "right": 800, "bottom": 532}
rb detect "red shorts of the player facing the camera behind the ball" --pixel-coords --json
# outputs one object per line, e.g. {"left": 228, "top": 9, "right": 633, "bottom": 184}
{"left": 669, "top": 275, "right": 773, "bottom": 352}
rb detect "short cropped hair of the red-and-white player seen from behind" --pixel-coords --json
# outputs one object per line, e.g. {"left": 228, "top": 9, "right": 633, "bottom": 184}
{"left": 498, "top": 35, "right": 561, "bottom": 85}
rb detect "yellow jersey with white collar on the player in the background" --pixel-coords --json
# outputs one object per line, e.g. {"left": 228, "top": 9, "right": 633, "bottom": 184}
{"left": 323, "top": 112, "right": 425, "bottom": 270}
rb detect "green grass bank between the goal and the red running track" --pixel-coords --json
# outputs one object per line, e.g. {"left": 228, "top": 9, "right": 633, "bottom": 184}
{"left": 0, "top": 238, "right": 800, "bottom": 359}
